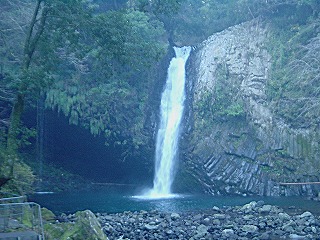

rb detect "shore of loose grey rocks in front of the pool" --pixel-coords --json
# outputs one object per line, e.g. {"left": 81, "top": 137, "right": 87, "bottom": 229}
{"left": 87, "top": 201, "right": 320, "bottom": 240}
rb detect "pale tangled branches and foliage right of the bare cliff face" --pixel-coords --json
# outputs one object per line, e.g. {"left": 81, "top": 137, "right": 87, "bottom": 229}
{"left": 267, "top": 6, "right": 320, "bottom": 127}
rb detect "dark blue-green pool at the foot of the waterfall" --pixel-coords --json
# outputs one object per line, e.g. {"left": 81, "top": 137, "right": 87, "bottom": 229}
{"left": 29, "top": 186, "right": 320, "bottom": 214}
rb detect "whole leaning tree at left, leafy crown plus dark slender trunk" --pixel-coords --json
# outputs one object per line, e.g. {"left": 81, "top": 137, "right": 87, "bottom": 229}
{"left": 0, "top": 0, "right": 94, "bottom": 192}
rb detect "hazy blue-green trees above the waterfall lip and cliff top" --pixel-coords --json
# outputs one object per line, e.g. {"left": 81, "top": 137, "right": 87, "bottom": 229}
{"left": 136, "top": 0, "right": 320, "bottom": 45}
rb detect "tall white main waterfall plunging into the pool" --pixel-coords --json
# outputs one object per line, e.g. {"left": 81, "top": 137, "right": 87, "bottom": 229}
{"left": 148, "top": 47, "right": 191, "bottom": 198}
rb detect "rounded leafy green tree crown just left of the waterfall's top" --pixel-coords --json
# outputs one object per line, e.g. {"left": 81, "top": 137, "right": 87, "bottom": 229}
{"left": 91, "top": 10, "right": 167, "bottom": 79}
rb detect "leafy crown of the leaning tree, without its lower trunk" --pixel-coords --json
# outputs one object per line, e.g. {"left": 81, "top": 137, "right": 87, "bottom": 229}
{"left": 0, "top": 0, "right": 94, "bottom": 97}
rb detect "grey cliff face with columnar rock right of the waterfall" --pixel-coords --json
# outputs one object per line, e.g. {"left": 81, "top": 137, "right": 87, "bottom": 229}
{"left": 184, "top": 20, "right": 320, "bottom": 196}
